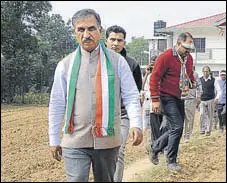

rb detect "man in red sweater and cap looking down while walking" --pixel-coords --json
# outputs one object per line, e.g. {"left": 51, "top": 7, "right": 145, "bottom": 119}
{"left": 150, "top": 32, "right": 196, "bottom": 171}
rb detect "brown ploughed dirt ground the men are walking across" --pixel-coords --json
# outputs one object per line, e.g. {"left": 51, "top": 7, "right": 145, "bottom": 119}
{"left": 1, "top": 105, "right": 226, "bottom": 182}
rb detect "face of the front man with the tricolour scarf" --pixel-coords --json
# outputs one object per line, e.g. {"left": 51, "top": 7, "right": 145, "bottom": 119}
{"left": 74, "top": 15, "right": 102, "bottom": 51}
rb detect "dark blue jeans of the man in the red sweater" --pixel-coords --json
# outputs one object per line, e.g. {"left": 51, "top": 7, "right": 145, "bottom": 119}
{"left": 152, "top": 96, "right": 184, "bottom": 163}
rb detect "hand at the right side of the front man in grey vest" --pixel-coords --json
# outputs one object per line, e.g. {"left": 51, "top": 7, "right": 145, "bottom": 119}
{"left": 129, "top": 127, "right": 143, "bottom": 146}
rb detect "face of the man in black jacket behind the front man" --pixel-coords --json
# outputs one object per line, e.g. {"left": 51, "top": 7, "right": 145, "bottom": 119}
{"left": 106, "top": 32, "right": 125, "bottom": 53}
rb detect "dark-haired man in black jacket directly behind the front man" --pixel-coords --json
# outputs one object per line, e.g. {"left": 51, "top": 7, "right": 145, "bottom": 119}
{"left": 106, "top": 25, "right": 142, "bottom": 182}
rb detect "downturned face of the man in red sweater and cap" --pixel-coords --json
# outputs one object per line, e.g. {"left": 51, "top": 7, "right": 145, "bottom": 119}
{"left": 178, "top": 37, "right": 194, "bottom": 57}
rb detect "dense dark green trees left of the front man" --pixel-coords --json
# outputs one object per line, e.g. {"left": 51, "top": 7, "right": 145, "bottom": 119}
{"left": 1, "top": 1, "right": 77, "bottom": 102}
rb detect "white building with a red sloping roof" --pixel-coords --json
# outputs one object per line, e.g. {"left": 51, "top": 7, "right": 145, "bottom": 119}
{"left": 148, "top": 12, "right": 226, "bottom": 76}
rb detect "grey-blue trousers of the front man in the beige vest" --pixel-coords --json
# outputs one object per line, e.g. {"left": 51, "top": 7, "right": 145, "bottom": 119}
{"left": 62, "top": 147, "right": 119, "bottom": 182}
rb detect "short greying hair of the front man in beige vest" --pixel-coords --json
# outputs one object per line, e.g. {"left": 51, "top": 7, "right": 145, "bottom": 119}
{"left": 72, "top": 9, "right": 101, "bottom": 28}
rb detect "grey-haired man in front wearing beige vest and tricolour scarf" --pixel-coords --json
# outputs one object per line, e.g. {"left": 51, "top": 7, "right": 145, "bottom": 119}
{"left": 49, "top": 9, "right": 143, "bottom": 182}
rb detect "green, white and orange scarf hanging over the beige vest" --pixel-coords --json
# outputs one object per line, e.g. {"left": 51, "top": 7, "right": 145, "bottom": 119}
{"left": 64, "top": 41, "right": 115, "bottom": 137}
